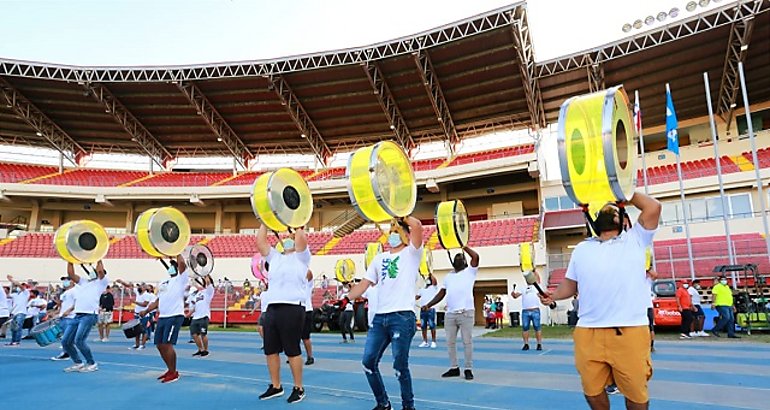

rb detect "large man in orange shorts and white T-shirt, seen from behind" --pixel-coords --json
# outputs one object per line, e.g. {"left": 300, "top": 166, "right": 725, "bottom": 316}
{"left": 540, "top": 192, "right": 661, "bottom": 409}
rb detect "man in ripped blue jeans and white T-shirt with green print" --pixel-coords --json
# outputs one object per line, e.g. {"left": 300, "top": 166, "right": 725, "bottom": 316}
{"left": 348, "top": 216, "right": 423, "bottom": 410}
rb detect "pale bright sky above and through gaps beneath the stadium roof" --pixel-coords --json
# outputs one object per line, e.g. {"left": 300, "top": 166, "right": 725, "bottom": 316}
{"left": 0, "top": 0, "right": 729, "bottom": 168}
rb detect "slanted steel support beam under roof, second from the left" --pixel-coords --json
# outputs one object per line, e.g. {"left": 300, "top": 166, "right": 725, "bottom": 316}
{"left": 83, "top": 83, "right": 172, "bottom": 169}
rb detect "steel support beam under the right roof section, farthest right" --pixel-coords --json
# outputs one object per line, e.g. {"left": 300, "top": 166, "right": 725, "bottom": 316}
{"left": 717, "top": 7, "right": 754, "bottom": 126}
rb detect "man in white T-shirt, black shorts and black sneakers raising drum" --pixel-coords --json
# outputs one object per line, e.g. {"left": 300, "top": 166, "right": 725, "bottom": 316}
{"left": 257, "top": 224, "right": 310, "bottom": 403}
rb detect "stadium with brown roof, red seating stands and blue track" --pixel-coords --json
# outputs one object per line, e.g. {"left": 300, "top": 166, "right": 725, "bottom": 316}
{"left": 0, "top": 0, "right": 770, "bottom": 409}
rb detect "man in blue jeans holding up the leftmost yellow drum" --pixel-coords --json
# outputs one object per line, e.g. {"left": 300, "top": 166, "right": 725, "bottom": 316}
{"left": 62, "top": 261, "right": 110, "bottom": 372}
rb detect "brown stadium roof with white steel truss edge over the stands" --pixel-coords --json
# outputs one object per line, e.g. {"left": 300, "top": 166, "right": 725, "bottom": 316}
{"left": 0, "top": 0, "right": 770, "bottom": 168}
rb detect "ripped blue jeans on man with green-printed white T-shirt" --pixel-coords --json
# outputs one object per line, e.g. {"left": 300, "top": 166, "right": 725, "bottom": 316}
{"left": 362, "top": 311, "right": 417, "bottom": 408}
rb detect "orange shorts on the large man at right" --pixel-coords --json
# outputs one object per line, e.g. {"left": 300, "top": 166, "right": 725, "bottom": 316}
{"left": 573, "top": 326, "right": 652, "bottom": 403}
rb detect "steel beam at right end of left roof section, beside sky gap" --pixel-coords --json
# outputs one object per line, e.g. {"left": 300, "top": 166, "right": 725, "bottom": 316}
{"left": 511, "top": 7, "right": 546, "bottom": 130}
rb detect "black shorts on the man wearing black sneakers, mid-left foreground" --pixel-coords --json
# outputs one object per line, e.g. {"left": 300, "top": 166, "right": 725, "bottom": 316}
{"left": 262, "top": 303, "right": 305, "bottom": 357}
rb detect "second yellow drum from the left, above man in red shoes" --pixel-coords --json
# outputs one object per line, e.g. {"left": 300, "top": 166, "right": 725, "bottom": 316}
{"left": 148, "top": 207, "right": 190, "bottom": 256}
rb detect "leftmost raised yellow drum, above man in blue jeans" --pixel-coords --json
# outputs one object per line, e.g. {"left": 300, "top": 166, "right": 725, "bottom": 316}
{"left": 54, "top": 220, "right": 110, "bottom": 263}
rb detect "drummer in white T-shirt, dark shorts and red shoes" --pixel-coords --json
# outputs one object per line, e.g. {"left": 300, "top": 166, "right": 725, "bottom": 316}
{"left": 139, "top": 255, "right": 190, "bottom": 383}
